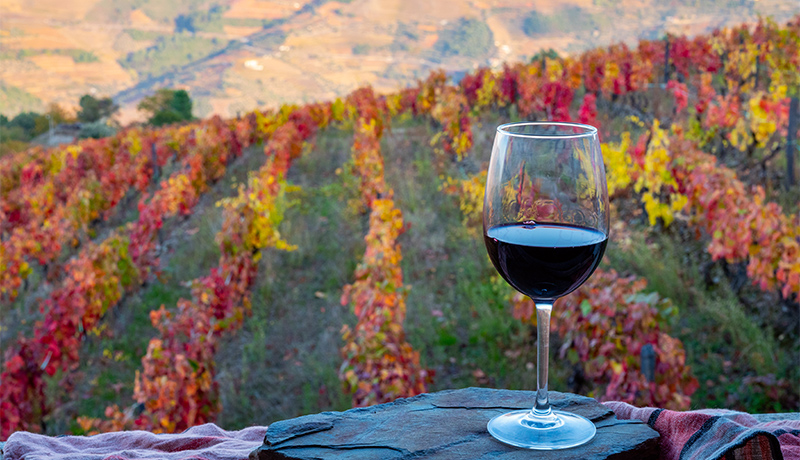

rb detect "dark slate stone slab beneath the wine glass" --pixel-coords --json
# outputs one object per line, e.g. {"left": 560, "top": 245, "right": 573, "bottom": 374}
{"left": 250, "top": 388, "right": 658, "bottom": 460}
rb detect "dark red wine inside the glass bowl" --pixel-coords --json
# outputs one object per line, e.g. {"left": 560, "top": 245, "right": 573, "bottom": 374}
{"left": 483, "top": 222, "right": 608, "bottom": 300}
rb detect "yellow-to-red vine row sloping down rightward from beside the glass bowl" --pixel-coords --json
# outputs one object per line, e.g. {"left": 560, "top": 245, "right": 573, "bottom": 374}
{"left": 603, "top": 121, "right": 800, "bottom": 298}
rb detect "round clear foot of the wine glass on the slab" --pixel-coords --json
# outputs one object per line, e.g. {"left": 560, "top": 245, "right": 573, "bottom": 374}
{"left": 487, "top": 410, "right": 597, "bottom": 450}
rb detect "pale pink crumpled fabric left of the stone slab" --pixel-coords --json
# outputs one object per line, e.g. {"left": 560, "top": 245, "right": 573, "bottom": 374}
{"left": 3, "top": 423, "right": 267, "bottom": 460}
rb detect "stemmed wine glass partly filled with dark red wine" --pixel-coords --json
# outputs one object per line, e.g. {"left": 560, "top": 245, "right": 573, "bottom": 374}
{"left": 483, "top": 122, "right": 608, "bottom": 450}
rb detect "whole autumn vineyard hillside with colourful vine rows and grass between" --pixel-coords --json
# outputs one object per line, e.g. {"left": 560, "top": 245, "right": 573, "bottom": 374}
{"left": 0, "top": 14, "right": 800, "bottom": 440}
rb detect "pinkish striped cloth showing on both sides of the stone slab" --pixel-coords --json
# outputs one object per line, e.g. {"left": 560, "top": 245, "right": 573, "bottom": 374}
{"left": 0, "top": 408, "right": 800, "bottom": 460}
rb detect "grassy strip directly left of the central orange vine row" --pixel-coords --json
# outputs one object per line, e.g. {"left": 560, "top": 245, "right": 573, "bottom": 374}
{"left": 217, "top": 127, "right": 366, "bottom": 426}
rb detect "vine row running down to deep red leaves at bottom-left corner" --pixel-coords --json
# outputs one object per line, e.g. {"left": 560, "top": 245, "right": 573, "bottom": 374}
{"left": 0, "top": 114, "right": 262, "bottom": 438}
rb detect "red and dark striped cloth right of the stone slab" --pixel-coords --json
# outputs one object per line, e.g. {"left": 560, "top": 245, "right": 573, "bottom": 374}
{"left": 604, "top": 401, "right": 800, "bottom": 460}
